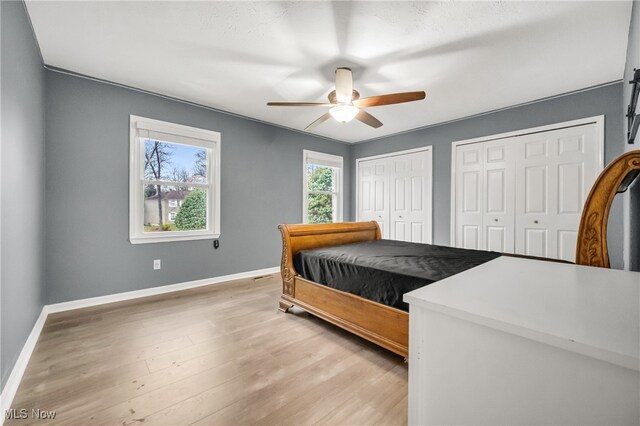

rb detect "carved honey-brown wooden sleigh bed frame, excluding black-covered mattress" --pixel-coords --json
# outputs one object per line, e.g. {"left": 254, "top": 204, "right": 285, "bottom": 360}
{"left": 279, "top": 151, "right": 640, "bottom": 358}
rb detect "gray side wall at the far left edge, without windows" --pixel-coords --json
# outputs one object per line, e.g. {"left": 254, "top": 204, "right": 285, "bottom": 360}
{"left": 0, "top": 1, "right": 45, "bottom": 388}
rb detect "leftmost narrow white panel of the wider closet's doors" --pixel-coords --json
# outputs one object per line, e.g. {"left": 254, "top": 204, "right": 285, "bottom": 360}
{"left": 454, "top": 143, "right": 485, "bottom": 249}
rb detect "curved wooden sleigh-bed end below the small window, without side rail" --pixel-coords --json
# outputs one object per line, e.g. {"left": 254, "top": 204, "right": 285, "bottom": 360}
{"left": 278, "top": 221, "right": 381, "bottom": 294}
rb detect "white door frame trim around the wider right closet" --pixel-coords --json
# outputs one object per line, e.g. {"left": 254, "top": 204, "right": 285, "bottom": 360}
{"left": 449, "top": 115, "right": 605, "bottom": 247}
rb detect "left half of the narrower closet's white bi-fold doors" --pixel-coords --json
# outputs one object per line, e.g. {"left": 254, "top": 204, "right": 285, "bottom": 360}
{"left": 358, "top": 159, "right": 389, "bottom": 238}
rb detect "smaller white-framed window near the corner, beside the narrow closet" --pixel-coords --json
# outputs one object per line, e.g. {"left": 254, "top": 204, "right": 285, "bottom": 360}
{"left": 302, "top": 150, "right": 342, "bottom": 223}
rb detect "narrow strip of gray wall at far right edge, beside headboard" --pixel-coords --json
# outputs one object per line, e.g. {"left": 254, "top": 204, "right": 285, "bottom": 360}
{"left": 617, "top": 2, "right": 640, "bottom": 271}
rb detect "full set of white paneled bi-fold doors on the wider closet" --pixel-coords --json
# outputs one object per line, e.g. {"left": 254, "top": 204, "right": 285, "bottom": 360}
{"left": 452, "top": 117, "right": 603, "bottom": 261}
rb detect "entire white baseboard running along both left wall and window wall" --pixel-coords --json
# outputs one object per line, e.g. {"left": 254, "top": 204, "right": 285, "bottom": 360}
{"left": 0, "top": 266, "right": 280, "bottom": 426}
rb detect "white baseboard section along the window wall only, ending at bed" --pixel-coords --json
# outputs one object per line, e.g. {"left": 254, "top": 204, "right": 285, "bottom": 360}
{"left": 47, "top": 266, "right": 280, "bottom": 314}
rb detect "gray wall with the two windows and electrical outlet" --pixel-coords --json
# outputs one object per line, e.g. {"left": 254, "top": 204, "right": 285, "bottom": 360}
{"left": 45, "top": 71, "right": 351, "bottom": 303}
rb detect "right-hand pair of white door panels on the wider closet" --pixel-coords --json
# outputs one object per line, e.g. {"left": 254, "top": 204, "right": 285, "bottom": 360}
{"left": 515, "top": 124, "right": 600, "bottom": 261}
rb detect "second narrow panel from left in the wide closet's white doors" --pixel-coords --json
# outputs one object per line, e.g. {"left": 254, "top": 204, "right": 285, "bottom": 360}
{"left": 481, "top": 139, "right": 516, "bottom": 253}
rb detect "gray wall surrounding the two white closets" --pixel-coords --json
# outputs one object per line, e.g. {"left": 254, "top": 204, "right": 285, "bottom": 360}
{"left": 351, "top": 83, "right": 624, "bottom": 268}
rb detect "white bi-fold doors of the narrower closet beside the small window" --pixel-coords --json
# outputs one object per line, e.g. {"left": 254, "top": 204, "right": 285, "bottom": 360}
{"left": 357, "top": 147, "right": 432, "bottom": 243}
